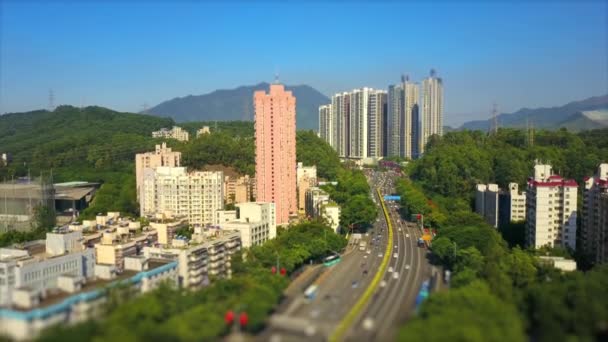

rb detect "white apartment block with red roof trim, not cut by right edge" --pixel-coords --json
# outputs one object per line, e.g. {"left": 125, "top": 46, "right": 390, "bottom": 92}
{"left": 526, "top": 164, "right": 578, "bottom": 250}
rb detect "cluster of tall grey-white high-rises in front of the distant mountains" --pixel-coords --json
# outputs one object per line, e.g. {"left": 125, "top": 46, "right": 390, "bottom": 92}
{"left": 319, "top": 69, "right": 444, "bottom": 160}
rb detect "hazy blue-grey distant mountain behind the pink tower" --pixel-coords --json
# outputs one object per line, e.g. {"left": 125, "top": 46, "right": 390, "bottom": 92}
{"left": 145, "top": 82, "right": 330, "bottom": 130}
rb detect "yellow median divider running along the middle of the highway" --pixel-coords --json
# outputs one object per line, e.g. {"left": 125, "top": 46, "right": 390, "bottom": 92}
{"left": 329, "top": 189, "right": 393, "bottom": 342}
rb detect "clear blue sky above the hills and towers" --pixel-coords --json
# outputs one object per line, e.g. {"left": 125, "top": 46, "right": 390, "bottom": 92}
{"left": 0, "top": 0, "right": 608, "bottom": 125}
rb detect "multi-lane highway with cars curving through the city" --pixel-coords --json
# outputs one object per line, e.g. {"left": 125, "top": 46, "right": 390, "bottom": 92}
{"left": 258, "top": 172, "right": 431, "bottom": 342}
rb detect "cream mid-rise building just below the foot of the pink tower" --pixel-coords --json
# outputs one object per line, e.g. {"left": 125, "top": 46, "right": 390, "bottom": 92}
{"left": 219, "top": 202, "right": 277, "bottom": 248}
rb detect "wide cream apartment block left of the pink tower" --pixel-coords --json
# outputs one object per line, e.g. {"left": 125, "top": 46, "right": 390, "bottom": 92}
{"left": 140, "top": 167, "right": 223, "bottom": 225}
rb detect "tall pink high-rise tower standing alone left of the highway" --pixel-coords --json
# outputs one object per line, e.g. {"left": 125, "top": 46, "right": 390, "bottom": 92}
{"left": 253, "top": 84, "right": 297, "bottom": 224}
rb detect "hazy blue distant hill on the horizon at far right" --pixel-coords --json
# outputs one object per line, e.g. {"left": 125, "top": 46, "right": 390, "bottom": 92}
{"left": 460, "top": 95, "right": 608, "bottom": 131}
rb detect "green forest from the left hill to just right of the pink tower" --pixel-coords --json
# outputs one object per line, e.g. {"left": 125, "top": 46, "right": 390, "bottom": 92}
{"left": 0, "top": 106, "right": 340, "bottom": 217}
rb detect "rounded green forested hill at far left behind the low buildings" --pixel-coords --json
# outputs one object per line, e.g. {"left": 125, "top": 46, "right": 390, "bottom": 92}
{"left": 0, "top": 106, "right": 173, "bottom": 176}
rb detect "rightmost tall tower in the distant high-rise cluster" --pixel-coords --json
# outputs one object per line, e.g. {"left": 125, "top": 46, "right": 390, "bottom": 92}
{"left": 419, "top": 69, "right": 443, "bottom": 154}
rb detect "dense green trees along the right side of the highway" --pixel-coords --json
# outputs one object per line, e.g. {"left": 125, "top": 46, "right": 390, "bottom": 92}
{"left": 398, "top": 130, "right": 608, "bottom": 342}
